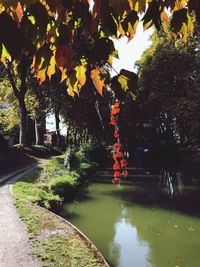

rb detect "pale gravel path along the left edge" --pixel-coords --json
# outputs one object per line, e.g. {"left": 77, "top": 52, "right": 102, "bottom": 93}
{"left": 0, "top": 170, "right": 41, "bottom": 267}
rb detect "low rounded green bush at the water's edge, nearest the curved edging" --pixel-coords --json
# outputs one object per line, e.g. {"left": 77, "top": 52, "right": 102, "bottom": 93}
{"left": 50, "top": 174, "right": 78, "bottom": 198}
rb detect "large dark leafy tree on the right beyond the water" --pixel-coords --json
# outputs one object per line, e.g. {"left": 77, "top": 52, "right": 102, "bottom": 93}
{"left": 137, "top": 25, "right": 200, "bottom": 144}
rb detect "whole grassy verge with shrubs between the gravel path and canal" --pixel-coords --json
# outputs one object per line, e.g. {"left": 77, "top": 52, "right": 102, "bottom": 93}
{"left": 13, "top": 157, "right": 105, "bottom": 267}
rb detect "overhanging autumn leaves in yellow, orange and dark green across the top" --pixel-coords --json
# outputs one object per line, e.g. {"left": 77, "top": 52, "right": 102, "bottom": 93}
{"left": 0, "top": 0, "right": 200, "bottom": 97}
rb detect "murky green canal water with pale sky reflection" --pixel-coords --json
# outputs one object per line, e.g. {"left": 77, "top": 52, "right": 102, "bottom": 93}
{"left": 64, "top": 177, "right": 200, "bottom": 267}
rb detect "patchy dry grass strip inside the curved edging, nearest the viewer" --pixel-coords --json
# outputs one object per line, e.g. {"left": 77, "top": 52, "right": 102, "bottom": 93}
{"left": 16, "top": 199, "right": 105, "bottom": 267}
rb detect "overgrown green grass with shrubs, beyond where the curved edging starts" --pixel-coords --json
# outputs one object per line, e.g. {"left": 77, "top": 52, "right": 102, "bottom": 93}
{"left": 13, "top": 157, "right": 79, "bottom": 211}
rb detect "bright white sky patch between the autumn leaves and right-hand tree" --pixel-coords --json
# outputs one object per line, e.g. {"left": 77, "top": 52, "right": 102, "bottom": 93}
{"left": 112, "top": 22, "right": 153, "bottom": 75}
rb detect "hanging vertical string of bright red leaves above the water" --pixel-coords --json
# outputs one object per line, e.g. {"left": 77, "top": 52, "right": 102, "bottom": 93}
{"left": 110, "top": 101, "right": 128, "bottom": 184}
